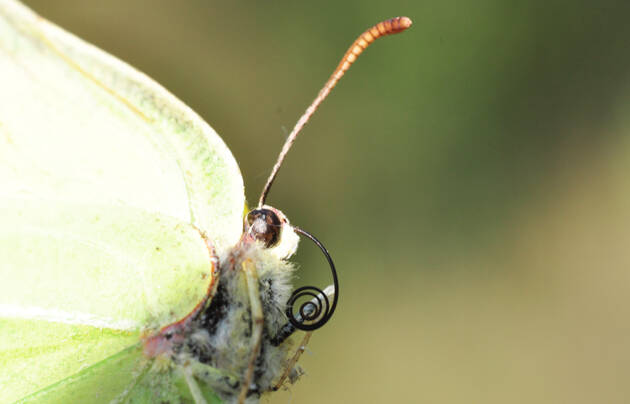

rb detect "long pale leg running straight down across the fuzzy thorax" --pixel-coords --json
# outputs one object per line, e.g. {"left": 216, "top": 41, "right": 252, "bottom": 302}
{"left": 238, "top": 260, "right": 264, "bottom": 404}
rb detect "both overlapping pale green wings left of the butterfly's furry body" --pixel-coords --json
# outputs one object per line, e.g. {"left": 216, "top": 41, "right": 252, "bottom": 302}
{"left": 0, "top": 0, "right": 244, "bottom": 402}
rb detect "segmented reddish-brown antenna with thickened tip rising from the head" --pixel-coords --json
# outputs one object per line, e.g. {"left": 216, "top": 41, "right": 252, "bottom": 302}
{"left": 258, "top": 17, "right": 411, "bottom": 209}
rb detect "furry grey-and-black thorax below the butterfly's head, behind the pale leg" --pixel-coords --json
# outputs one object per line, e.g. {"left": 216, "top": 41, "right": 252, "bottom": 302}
{"left": 184, "top": 238, "right": 294, "bottom": 391}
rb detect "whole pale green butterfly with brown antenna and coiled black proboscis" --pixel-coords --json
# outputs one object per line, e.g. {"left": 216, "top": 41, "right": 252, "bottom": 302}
{"left": 0, "top": 0, "right": 411, "bottom": 404}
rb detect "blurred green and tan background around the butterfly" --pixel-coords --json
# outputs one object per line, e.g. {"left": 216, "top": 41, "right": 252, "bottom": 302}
{"left": 26, "top": 0, "right": 630, "bottom": 403}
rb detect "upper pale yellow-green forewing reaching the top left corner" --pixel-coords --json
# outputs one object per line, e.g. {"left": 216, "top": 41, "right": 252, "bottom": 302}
{"left": 0, "top": 0, "right": 244, "bottom": 252}
